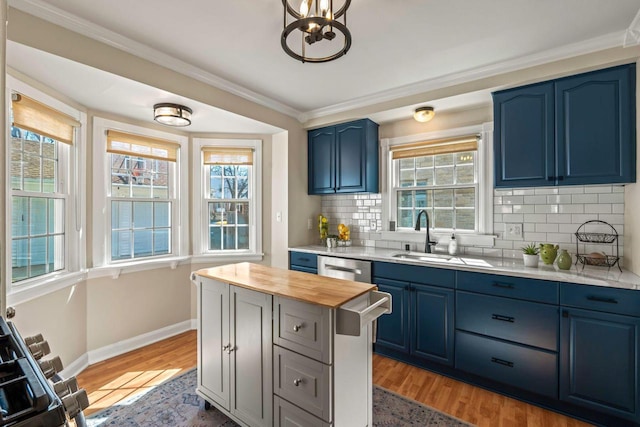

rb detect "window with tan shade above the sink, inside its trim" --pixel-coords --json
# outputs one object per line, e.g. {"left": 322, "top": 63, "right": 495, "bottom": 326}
{"left": 390, "top": 135, "right": 479, "bottom": 232}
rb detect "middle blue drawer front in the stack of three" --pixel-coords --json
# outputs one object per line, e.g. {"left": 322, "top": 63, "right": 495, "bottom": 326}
{"left": 456, "top": 291, "right": 559, "bottom": 351}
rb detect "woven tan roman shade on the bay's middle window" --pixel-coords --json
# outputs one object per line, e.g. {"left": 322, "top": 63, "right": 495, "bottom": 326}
{"left": 107, "top": 129, "right": 180, "bottom": 162}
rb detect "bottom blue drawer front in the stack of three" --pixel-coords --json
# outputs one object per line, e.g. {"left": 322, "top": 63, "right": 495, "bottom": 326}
{"left": 456, "top": 331, "right": 558, "bottom": 399}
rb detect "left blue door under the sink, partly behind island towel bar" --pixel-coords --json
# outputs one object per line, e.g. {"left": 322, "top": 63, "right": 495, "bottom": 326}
{"left": 375, "top": 279, "right": 409, "bottom": 353}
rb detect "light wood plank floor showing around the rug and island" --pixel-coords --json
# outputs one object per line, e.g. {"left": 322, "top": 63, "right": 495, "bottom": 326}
{"left": 78, "top": 331, "right": 588, "bottom": 427}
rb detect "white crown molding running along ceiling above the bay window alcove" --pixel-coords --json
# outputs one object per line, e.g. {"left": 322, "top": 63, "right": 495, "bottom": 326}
{"left": 8, "top": 0, "right": 301, "bottom": 118}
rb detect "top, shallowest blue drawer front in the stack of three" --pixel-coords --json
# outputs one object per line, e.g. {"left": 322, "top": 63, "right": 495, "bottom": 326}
{"left": 457, "top": 271, "right": 558, "bottom": 304}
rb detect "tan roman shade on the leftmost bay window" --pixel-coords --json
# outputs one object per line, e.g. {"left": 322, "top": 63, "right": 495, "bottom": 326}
{"left": 11, "top": 94, "right": 80, "bottom": 145}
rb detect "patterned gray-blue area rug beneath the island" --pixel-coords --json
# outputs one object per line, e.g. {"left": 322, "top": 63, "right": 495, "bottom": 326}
{"left": 85, "top": 369, "right": 471, "bottom": 427}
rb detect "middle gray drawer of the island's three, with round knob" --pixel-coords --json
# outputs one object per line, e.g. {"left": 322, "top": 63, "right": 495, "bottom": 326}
{"left": 273, "top": 346, "right": 332, "bottom": 422}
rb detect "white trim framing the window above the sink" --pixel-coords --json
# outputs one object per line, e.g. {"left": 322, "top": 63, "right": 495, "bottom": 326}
{"left": 380, "top": 123, "right": 497, "bottom": 246}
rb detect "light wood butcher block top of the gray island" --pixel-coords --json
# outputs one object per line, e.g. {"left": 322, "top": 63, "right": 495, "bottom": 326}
{"left": 194, "top": 262, "right": 378, "bottom": 308}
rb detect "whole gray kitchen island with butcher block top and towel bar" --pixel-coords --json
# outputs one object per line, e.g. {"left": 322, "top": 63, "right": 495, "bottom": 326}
{"left": 191, "top": 263, "right": 391, "bottom": 427}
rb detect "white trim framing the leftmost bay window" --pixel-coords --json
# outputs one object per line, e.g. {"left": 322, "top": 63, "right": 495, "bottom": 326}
{"left": 4, "top": 75, "right": 87, "bottom": 304}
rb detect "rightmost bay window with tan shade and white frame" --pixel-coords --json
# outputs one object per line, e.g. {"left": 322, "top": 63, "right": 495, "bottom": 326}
{"left": 194, "top": 139, "right": 262, "bottom": 257}
